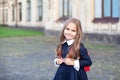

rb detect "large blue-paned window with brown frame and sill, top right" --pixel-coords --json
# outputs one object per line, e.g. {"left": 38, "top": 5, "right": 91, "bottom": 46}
{"left": 93, "top": 0, "right": 119, "bottom": 23}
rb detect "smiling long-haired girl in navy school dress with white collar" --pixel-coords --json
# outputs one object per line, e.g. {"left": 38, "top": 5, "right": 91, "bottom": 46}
{"left": 53, "top": 18, "right": 92, "bottom": 80}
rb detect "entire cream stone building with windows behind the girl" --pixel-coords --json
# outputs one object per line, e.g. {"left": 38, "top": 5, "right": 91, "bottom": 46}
{"left": 0, "top": 0, "right": 120, "bottom": 44}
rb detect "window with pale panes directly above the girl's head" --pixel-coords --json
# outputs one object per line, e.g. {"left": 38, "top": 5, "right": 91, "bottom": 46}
{"left": 58, "top": 0, "right": 72, "bottom": 21}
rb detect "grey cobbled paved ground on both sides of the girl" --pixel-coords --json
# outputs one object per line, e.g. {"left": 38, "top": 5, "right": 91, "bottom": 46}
{"left": 0, "top": 36, "right": 120, "bottom": 80}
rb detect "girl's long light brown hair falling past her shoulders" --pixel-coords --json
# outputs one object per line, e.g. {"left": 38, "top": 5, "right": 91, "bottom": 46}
{"left": 56, "top": 18, "right": 82, "bottom": 59}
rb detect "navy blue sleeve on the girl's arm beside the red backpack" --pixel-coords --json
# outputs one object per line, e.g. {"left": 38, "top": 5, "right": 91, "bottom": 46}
{"left": 79, "top": 43, "right": 92, "bottom": 68}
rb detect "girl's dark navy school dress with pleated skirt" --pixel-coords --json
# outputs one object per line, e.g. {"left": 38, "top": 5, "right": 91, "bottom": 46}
{"left": 53, "top": 42, "right": 92, "bottom": 80}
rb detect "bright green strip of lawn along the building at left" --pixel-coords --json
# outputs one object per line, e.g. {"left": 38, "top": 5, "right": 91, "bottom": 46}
{"left": 0, "top": 26, "right": 43, "bottom": 37}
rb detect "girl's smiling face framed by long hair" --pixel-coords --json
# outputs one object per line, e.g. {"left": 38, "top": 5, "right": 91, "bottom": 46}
{"left": 64, "top": 23, "right": 77, "bottom": 40}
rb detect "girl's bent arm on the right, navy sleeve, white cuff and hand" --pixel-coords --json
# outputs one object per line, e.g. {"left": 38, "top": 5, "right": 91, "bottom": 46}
{"left": 63, "top": 44, "right": 92, "bottom": 71}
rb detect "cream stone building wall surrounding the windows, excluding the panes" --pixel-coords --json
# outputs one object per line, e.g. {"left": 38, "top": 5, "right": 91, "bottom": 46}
{"left": 0, "top": 0, "right": 120, "bottom": 43}
